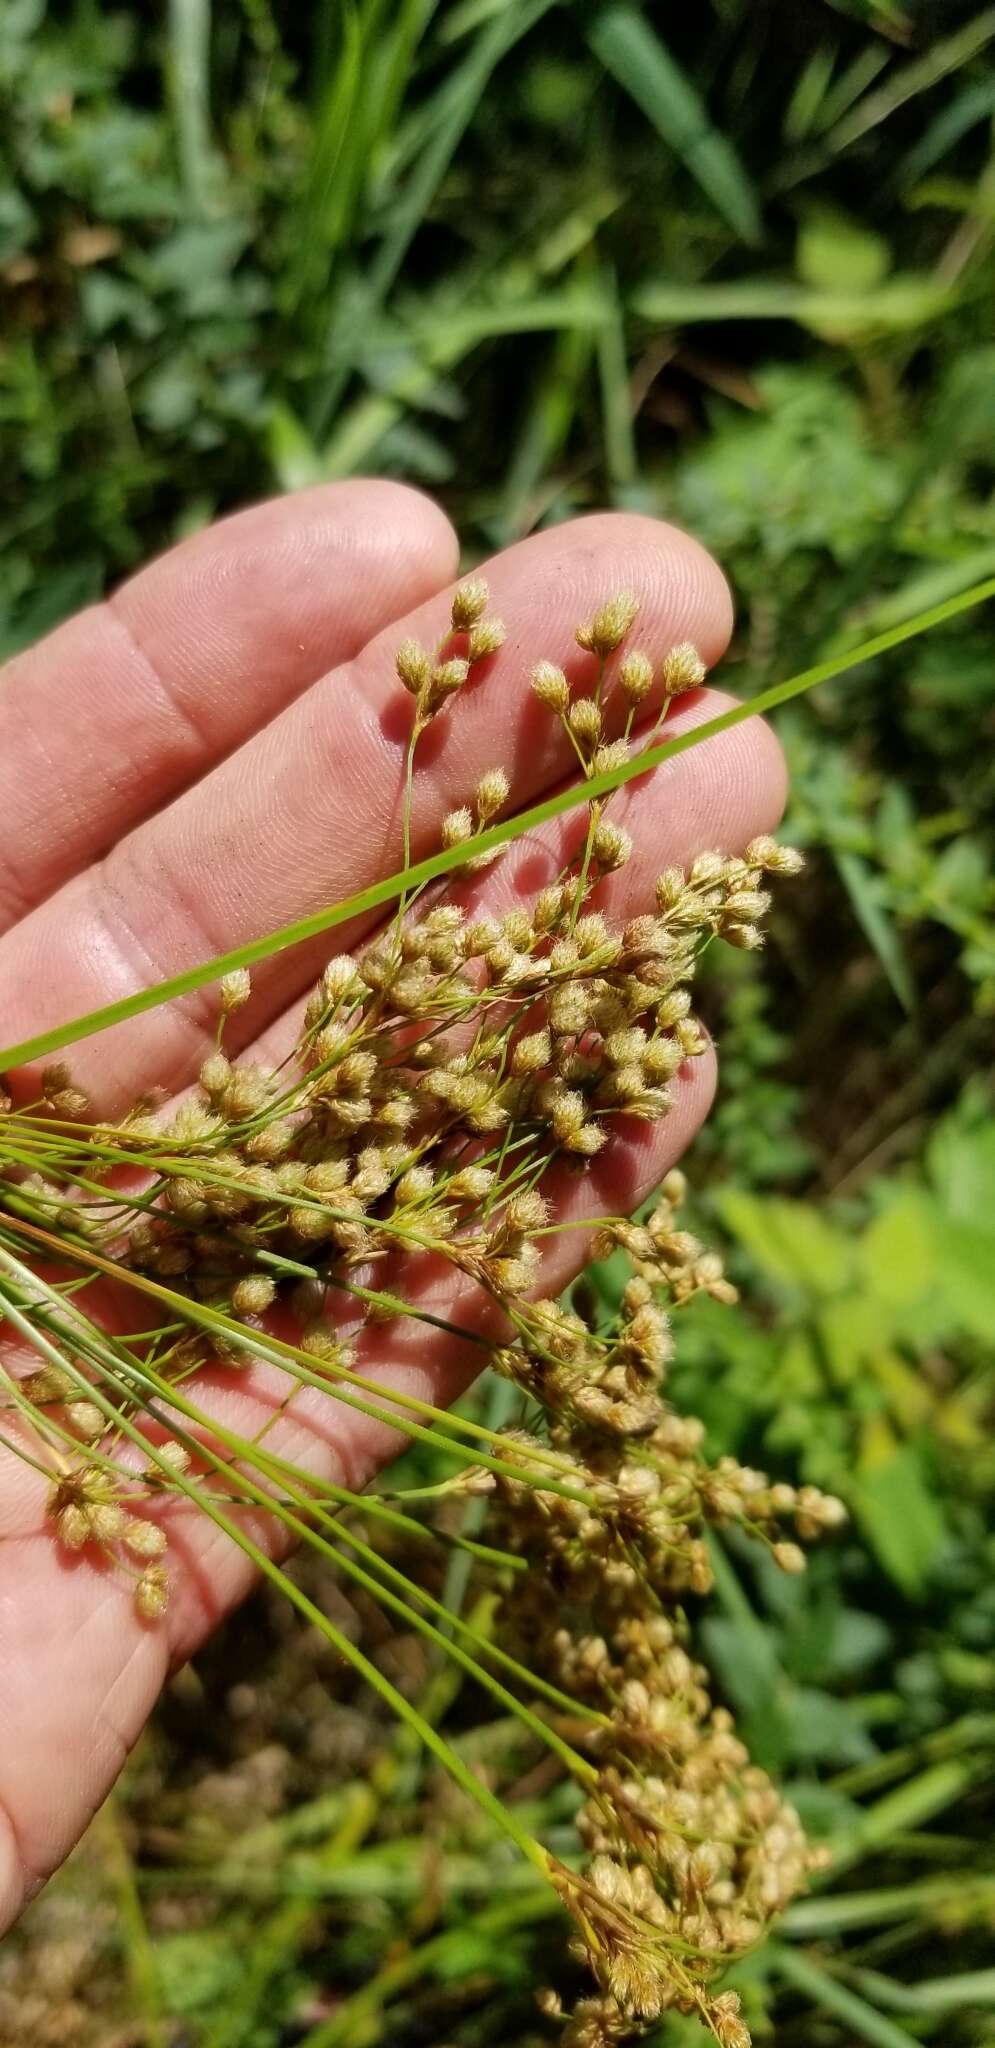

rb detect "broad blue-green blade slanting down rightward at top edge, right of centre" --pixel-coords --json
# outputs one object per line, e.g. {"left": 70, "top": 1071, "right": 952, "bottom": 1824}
{"left": 588, "top": 6, "right": 762, "bottom": 246}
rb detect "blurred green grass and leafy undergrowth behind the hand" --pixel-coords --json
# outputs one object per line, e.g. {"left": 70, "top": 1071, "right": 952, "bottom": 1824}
{"left": 0, "top": 0, "right": 995, "bottom": 2048}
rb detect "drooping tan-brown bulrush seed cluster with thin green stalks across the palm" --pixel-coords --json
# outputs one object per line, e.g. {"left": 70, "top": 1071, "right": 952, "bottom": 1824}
{"left": 0, "top": 580, "right": 841, "bottom": 2048}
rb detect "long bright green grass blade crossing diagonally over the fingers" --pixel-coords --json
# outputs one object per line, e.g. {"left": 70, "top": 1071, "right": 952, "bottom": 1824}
{"left": 0, "top": 575, "right": 995, "bottom": 1073}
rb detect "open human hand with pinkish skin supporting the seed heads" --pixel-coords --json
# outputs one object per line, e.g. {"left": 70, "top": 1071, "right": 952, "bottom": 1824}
{"left": 0, "top": 483, "right": 784, "bottom": 1925}
